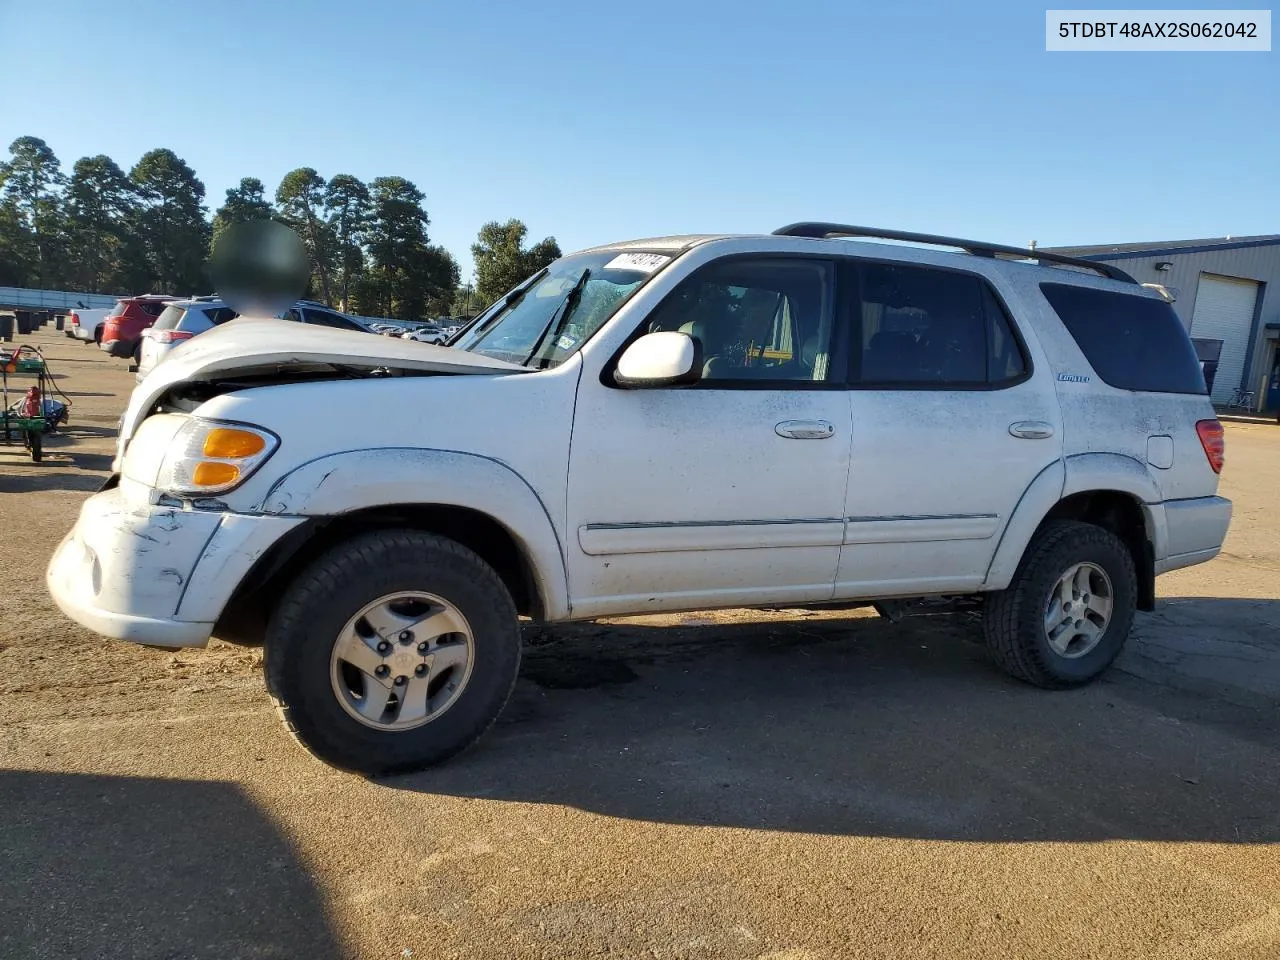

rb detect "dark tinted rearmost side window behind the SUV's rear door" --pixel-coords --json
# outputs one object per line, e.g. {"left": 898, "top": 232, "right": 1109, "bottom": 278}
{"left": 1041, "top": 283, "right": 1207, "bottom": 394}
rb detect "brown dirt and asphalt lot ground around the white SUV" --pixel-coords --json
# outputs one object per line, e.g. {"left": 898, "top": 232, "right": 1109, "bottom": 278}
{"left": 0, "top": 328, "right": 1280, "bottom": 960}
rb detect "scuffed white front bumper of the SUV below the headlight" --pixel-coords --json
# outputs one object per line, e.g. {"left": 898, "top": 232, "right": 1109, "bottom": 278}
{"left": 45, "top": 488, "right": 302, "bottom": 646}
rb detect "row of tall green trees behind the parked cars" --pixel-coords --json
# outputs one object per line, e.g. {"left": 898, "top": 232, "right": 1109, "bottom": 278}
{"left": 0, "top": 137, "right": 561, "bottom": 320}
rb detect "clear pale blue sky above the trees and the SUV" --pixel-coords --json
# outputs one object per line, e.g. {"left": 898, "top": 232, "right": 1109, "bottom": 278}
{"left": 0, "top": 0, "right": 1280, "bottom": 277}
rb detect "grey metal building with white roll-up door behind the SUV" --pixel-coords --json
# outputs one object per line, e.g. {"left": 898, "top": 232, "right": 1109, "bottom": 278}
{"left": 1052, "top": 234, "right": 1280, "bottom": 412}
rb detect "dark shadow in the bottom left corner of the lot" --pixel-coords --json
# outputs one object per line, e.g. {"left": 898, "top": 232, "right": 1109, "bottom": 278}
{"left": 0, "top": 771, "right": 348, "bottom": 960}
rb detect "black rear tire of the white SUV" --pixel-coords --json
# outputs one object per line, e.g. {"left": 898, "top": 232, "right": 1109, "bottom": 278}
{"left": 983, "top": 521, "right": 1138, "bottom": 689}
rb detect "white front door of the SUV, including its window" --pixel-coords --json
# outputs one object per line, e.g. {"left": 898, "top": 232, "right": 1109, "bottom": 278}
{"left": 564, "top": 257, "right": 850, "bottom": 617}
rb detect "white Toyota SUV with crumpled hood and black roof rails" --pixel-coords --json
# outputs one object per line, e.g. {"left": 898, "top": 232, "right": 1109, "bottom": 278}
{"left": 47, "top": 224, "right": 1231, "bottom": 774}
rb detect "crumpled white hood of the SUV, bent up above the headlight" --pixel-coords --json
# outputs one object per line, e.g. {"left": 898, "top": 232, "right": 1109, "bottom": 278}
{"left": 120, "top": 317, "right": 529, "bottom": 450}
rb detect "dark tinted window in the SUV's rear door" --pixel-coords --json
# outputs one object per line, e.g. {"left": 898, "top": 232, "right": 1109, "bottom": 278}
{"left": 855, "top": 264, "right": 1027, "bottom": 388}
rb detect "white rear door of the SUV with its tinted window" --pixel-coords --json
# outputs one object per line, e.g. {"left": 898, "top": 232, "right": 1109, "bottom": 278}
{"left": 836, "top": 260, "right": 1061, "bottom": 598}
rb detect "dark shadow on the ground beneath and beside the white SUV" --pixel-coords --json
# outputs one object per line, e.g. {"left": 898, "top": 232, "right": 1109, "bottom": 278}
{"left": 385, "top": 599, "right": 1280, "bottom": 844}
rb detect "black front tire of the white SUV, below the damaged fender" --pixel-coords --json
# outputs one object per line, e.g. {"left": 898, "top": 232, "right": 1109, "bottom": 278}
{"left": 265, "top": 530, "right": 520, "bottom": 777}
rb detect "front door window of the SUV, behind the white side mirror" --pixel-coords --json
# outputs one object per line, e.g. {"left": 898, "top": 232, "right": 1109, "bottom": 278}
{"left": 649, "top": 259, "right": 835, "bottom": 387}
